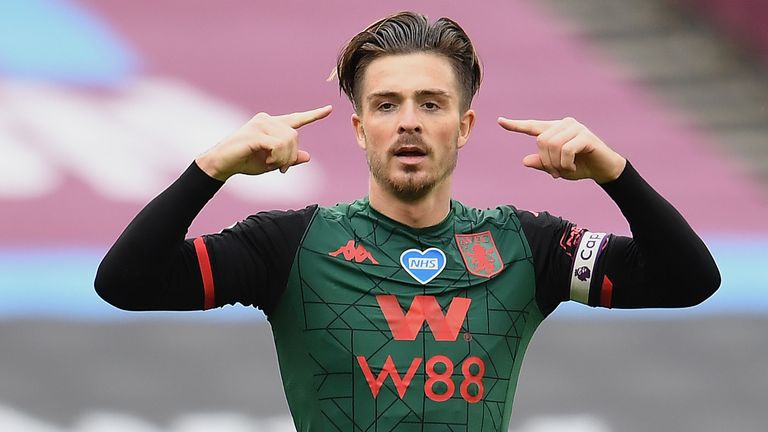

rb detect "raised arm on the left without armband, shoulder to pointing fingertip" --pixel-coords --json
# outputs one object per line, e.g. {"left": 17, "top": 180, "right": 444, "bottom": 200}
{"left": 95, "top": 107, "right": 330, "bottom": 310}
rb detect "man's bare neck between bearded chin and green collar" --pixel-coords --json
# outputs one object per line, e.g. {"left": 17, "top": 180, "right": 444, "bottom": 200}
{"left": 368, "top": 178, "right": 451, "bottom": 228}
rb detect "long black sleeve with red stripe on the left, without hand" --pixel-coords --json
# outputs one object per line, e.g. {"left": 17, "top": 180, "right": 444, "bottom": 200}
{"left": 94, "top": 163, "right": 317, "bottom": 311}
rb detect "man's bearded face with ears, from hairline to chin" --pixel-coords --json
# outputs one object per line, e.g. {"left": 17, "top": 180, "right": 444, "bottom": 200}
{"left": 352, "top": 53, "right": 474, "bottom": 201}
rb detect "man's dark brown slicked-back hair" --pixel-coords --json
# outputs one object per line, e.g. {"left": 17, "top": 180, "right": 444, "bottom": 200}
{"left": 336, "top": 12, "right": 482, "bottom": 110}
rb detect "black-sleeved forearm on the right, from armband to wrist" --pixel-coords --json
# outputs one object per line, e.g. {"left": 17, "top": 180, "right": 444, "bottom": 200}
{"left": 601, "top": 163, "right": 720, "bottom": 308}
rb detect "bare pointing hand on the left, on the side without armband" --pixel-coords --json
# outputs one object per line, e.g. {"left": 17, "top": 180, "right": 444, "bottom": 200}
{"left": 195, "top": 105, "right": 333, "bottom": 181}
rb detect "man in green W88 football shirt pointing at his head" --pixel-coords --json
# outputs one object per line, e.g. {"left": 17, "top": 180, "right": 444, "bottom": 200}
{"left": 96, "top": 12, "right": 720, "bottom": 431}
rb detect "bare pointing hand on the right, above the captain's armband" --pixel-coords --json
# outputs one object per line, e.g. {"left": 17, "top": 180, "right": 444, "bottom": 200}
{"left": 498, "top": 117, "right": 627, "bottom": 183}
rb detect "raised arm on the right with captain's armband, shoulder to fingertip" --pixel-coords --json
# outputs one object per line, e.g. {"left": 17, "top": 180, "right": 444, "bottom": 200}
{"left": 499, "top": 119, "right": 720, "bottom": 313}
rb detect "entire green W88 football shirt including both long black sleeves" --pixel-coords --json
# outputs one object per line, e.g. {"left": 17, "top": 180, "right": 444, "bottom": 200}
{"left": 95, "top": 163, "right": 720, "bottom": 432}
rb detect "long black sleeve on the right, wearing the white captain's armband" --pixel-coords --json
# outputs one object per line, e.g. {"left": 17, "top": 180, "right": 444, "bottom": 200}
{"left": 517, "top": 162, "right": 720, "bottom": 314}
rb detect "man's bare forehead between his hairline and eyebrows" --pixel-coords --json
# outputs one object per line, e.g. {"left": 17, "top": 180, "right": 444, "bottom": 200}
{"left": 361, "top": 53, "right": 459, "bottom": 100}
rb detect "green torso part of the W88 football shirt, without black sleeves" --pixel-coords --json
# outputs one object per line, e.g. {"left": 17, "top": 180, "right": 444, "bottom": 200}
{"left": 269, "top": 199, "right": 544, "bottom": 432}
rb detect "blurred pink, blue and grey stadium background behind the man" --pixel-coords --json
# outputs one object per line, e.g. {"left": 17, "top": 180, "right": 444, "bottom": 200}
{"left": 0, "top": 0, "right": 768, "bottom": 432}
